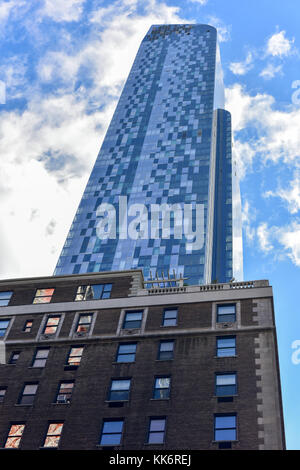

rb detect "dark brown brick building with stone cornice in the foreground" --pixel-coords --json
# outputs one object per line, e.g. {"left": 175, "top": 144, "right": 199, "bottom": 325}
{"left": 0, "top": 270, "right": 285, "bottom": 450}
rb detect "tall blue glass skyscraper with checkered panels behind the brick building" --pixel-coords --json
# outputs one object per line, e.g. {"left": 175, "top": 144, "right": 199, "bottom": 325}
{"left": 55, "top": 25, "right": 242, "bottom": 284}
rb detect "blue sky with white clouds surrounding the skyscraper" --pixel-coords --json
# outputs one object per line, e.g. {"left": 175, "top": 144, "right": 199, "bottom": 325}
{"left": 0, "top": 0, "right": 300, "bottom": 449}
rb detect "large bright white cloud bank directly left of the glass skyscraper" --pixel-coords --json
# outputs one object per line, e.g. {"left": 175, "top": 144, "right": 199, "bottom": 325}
{"left": 0, "top": 0, "right": 187, "bottom": 278}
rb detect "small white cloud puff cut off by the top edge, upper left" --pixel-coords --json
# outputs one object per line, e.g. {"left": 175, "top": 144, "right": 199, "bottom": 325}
{"left": 40, "top": 0, "right": 86, "bottom": 22}
